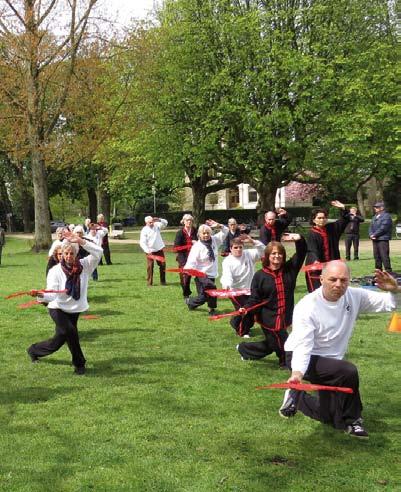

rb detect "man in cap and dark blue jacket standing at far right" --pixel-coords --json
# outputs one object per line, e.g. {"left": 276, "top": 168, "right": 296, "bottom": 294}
{"left": 369, "top": 202, "right": 393, "bottom": 272}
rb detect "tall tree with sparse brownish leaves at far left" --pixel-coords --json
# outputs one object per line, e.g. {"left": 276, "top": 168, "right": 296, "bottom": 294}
{"left": 0, "top": 0, "right": 97, "bottom": 251}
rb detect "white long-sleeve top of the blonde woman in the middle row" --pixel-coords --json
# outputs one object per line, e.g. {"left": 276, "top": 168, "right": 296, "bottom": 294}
{"left": 184, "top": 226, "right": 228, "bottom": 278}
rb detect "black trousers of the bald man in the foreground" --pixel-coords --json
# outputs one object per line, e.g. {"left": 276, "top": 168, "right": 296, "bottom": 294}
{"left": 286, "top": 352, "right": 362, "bottom": 429}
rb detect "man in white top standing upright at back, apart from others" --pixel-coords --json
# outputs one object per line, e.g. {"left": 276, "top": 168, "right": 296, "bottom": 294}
{"left": 139, "top": 215, "right": 167, "bottom": 287}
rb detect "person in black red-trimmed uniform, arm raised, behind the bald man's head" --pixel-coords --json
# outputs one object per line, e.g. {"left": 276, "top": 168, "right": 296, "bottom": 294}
{"left": 305, "top": 200, "right": 350, "bottom": 292}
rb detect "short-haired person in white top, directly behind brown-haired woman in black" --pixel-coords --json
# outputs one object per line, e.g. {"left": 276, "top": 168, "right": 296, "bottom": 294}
{"left": 220, "top": 234, "right": 265, "bottom": 338}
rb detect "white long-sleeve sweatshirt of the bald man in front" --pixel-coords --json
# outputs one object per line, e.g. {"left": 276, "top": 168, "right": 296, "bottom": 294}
{"left": 284, "top": 287, "right": 399, "bottom": 374}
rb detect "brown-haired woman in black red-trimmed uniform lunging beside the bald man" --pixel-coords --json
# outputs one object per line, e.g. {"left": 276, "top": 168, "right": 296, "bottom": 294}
{"left": 237, "top": 234, "right": 306, "bottom": 367}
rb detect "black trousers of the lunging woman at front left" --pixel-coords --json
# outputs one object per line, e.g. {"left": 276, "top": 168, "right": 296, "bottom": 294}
{"left": 28, "top": 309, "right": 86, "bottom": 367}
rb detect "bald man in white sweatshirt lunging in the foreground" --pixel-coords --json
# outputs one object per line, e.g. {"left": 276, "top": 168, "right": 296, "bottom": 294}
{"left": 279, "top": 260, "right": 401, "bottom": 438}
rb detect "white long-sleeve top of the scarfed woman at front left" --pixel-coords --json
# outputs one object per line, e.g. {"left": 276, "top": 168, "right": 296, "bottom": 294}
{"left": 38, "top": 241, "right": 103, "bottom": 313}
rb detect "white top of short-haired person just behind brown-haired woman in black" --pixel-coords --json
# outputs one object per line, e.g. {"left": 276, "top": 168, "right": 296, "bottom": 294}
{"left": 220, "top": 241, "right": 265, "bottom": 289}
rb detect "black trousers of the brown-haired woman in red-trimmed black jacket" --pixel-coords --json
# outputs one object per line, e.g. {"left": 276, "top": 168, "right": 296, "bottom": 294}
{"left": 238, "top": 328, "right": 288, "bottom": 366}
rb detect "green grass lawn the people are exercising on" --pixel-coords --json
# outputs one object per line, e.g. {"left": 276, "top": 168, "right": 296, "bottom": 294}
{"left": 0, "top": 236, "right": 401, "bottom": 492}
